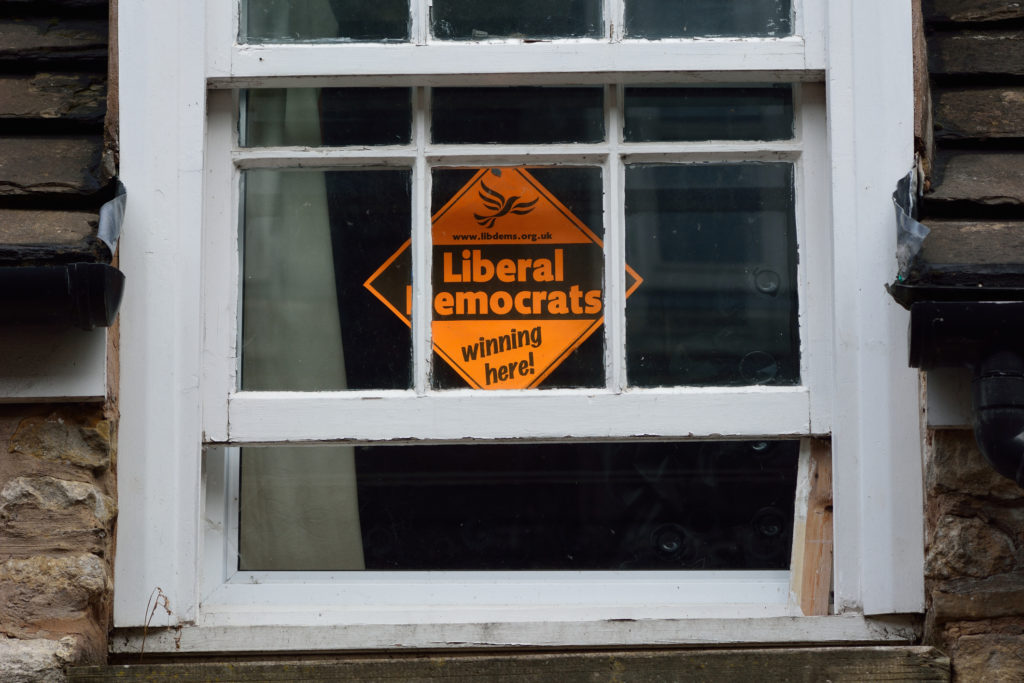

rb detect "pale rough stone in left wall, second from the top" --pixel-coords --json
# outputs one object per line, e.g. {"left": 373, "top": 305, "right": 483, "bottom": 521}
{"left": 0, "top": 476, "right": 117, "bottom": 559}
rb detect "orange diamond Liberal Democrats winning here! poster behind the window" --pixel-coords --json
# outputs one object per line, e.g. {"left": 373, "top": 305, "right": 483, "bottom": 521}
{"left": 366, "top": 168, "right": 642, "bottom": 389}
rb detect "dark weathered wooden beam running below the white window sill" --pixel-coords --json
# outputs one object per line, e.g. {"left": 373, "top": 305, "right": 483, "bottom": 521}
{"left": 69, "top": 647, "right": 949, "bottom": 683}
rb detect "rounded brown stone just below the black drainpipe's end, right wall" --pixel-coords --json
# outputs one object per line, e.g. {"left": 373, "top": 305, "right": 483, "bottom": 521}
{"left": 925, "top": 515, "right": 1015, "bottom": 579}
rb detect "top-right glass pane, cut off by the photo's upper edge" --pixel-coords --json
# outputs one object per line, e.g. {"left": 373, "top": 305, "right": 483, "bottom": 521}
{"left": 626, "top": 0, "right": 793, "bottom": 38}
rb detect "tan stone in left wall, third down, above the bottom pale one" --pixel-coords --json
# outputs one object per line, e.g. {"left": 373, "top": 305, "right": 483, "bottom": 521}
{"left": 0, "top": 554, "right": 109, "bottom": 635}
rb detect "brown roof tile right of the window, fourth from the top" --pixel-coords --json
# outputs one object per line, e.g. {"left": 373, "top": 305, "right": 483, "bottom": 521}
{"left": 926, "top": 151, "right": 1024, "bottom": 208}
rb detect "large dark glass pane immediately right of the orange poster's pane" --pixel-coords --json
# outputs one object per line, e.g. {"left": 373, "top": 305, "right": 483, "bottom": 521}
{"left": 626, "top": 163, "right": 800, "bottom": 387}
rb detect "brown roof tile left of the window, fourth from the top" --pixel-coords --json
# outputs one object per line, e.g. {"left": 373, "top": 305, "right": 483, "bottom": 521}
{"left": 0, "top": 135, "right": 106, "bottom": 197}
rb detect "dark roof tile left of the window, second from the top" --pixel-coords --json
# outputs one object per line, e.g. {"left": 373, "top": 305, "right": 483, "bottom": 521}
{"left": 0, "top": 18, "right": 108, "bottom": 65}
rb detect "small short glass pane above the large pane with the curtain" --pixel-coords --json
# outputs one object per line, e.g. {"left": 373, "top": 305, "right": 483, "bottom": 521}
{"left": 240, "top": 88, "right": 413, "bottom": 146}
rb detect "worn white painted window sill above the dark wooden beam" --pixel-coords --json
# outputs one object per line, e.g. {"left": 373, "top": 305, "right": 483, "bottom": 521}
{"left": 111, "top": 615, "right": 920, "bottom": 654}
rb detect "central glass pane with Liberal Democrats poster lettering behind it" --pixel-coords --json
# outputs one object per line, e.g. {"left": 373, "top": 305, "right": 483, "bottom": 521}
{"left": 431, "top": 168, "right": 604, "bottom": 389}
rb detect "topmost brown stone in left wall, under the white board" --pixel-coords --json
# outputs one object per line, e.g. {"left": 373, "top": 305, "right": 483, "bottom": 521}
{"left": 9, "top": 411, "right": 111, "bottom": 470}
